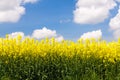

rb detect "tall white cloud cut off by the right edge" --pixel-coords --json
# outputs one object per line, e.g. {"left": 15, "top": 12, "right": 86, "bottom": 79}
{"left": 109, "top": 9, "right": 120, "bottom": 39}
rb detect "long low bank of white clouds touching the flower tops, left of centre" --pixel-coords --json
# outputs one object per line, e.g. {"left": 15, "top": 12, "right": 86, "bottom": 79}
{"left": 8, "top": 27, "right": 64, "bottom": 42}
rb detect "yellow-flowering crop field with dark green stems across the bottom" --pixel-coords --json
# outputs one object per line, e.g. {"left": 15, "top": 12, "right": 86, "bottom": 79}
{"left": 0, "top": 36, "right": 120, "bottom": 80}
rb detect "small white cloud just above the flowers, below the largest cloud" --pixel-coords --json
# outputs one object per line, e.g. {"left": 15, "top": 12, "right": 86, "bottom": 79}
{"left": 80, "top": 30, "right": 102, "bottom": 40}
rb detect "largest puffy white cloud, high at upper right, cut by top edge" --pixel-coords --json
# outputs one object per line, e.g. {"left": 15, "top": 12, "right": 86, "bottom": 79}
{"left": 73, "top": 0, "right": 116, "bottom": 24}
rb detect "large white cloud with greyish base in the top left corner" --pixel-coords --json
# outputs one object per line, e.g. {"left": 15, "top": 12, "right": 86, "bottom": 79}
{"left": 0, "top": 0, "right": 37, "bottom": 23}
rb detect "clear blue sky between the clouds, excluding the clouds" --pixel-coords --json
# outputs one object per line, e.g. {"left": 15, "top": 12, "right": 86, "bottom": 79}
{"left": 0, "top": 0, "right": 120, "bottom": 41}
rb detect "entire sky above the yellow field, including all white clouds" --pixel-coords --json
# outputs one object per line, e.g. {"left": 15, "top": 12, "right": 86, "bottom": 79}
{"left": 0, "top": 0, "right": 120, "bottom": 41}
